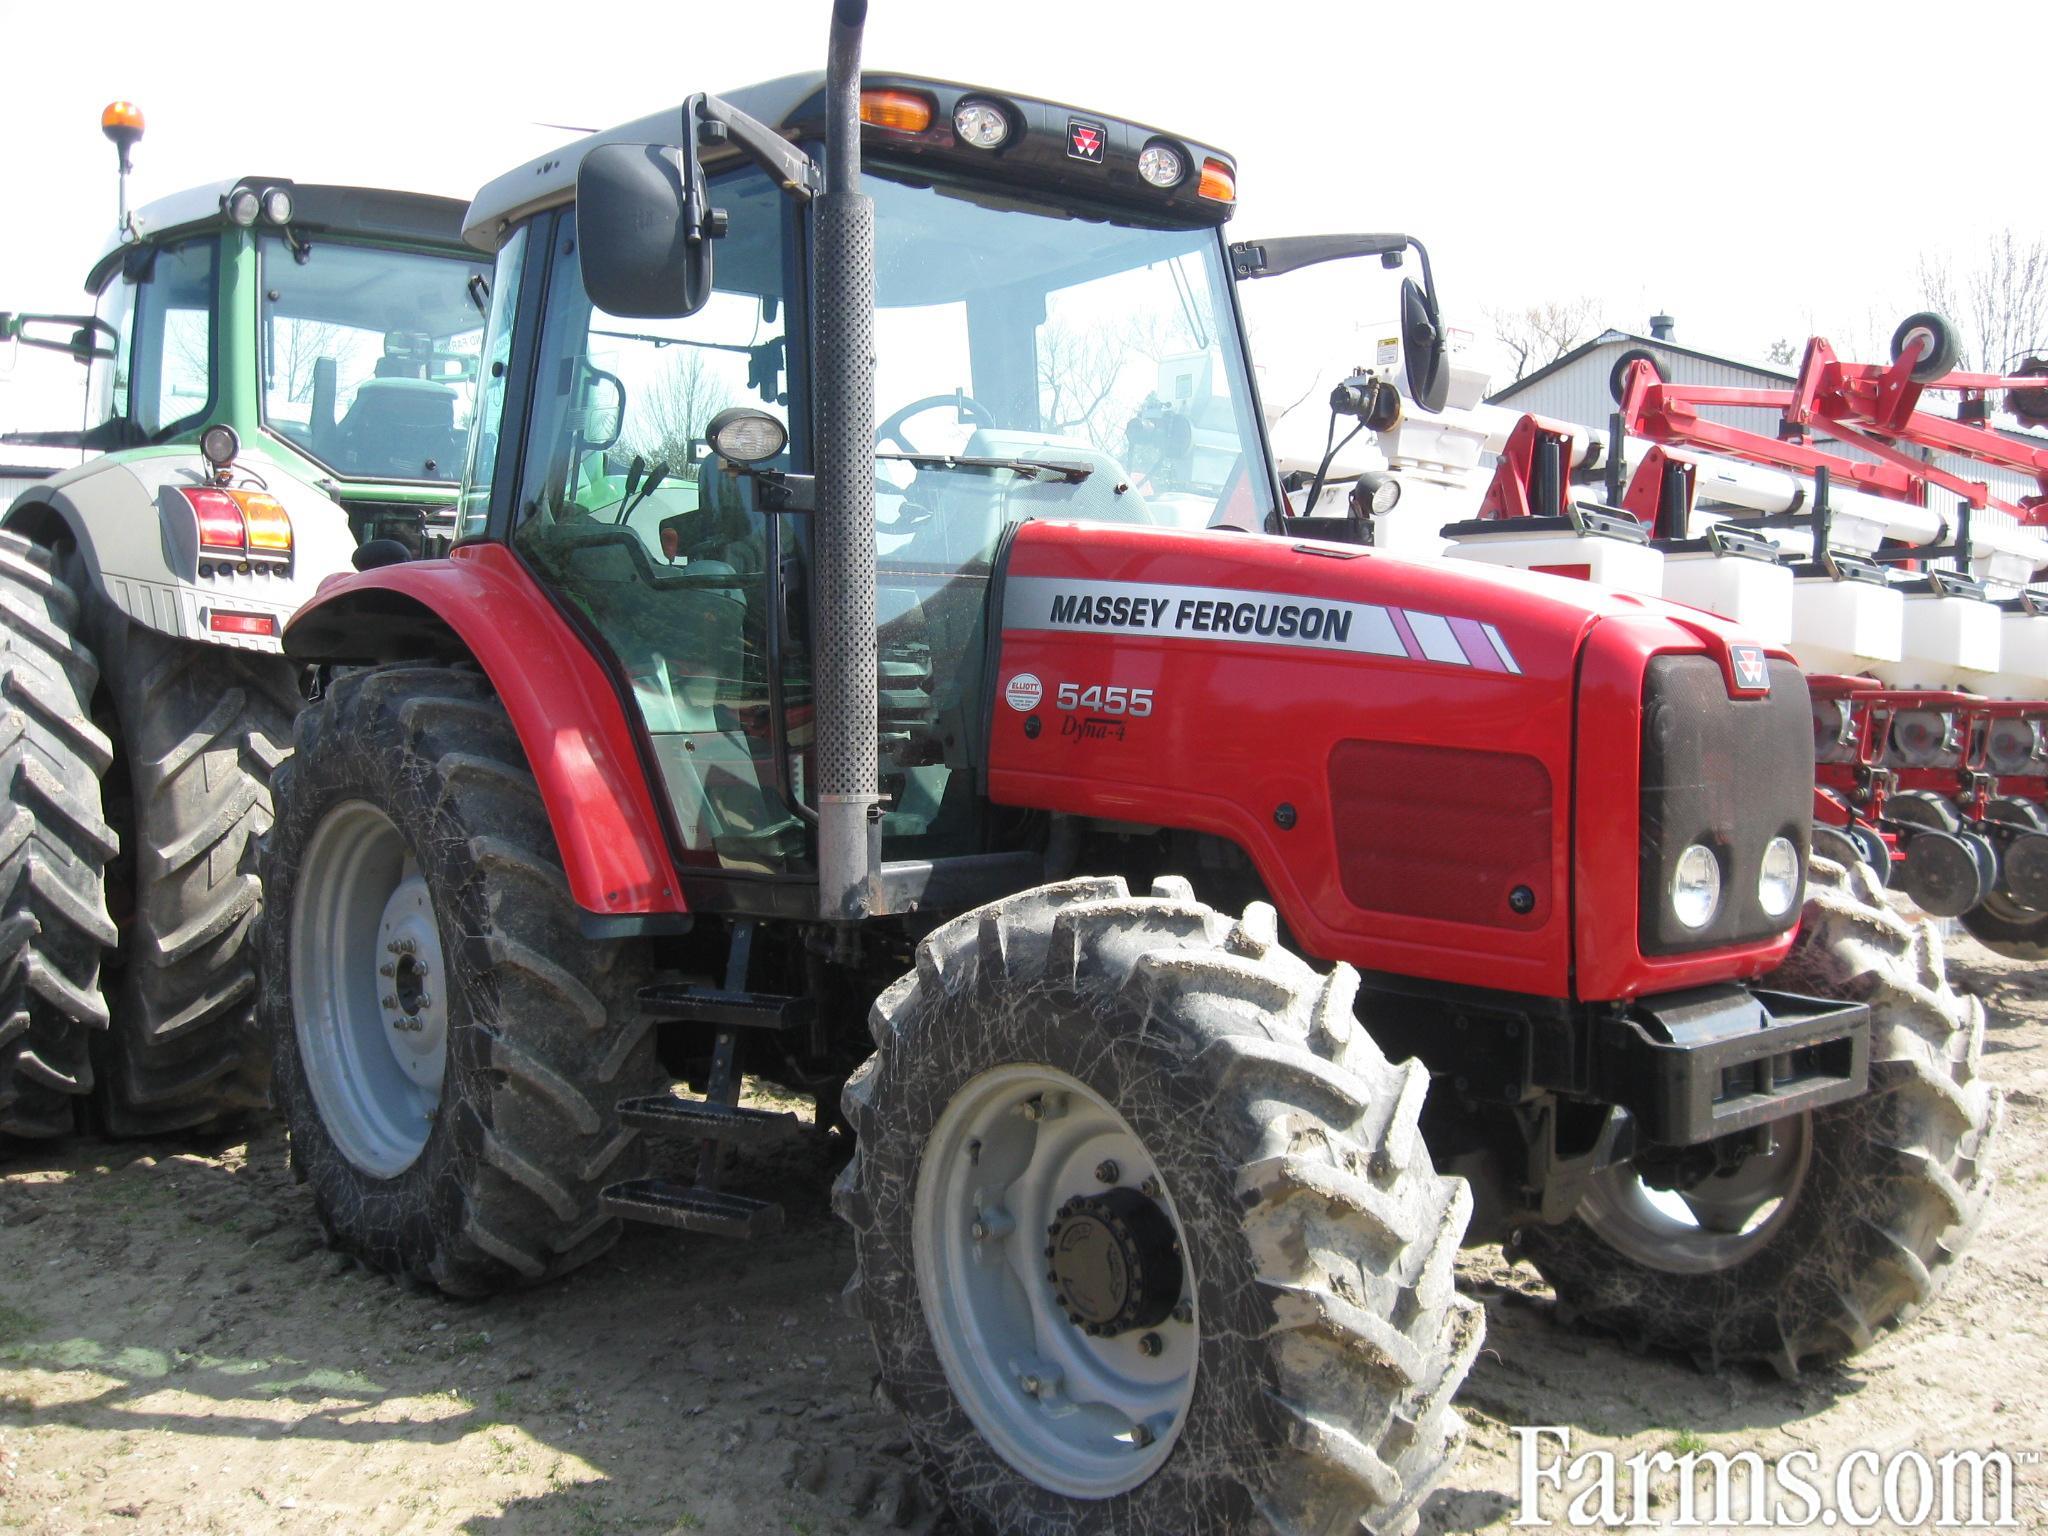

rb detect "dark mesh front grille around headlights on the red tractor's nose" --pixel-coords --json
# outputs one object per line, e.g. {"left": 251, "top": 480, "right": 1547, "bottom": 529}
{"left": 1636, "top": 655, "right": 1812, "bottom": 954}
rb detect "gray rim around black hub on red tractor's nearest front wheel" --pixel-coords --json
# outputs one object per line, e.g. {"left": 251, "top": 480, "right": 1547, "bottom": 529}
{"left": 911, "top": 1063, "right": 1200, "bottom": 1499}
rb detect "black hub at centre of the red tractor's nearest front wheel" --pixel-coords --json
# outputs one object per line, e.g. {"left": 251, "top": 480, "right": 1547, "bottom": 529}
{"left": 1044, "top": 1190, "right": 1182, "bottom": 1337}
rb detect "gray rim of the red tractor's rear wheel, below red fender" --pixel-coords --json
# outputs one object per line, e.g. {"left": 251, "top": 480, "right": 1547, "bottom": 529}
{"left": 291, "top": 801, "right": 449, "bottom": 1178}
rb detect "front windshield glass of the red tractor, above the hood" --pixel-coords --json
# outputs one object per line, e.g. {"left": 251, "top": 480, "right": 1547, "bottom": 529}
{"left": 864, "top": 176, "right": 1270, "bottom": 535}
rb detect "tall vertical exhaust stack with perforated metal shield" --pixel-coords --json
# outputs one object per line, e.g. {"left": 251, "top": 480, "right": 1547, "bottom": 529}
{"left": 811, "top": 0, "right": 881, "bottom": 922}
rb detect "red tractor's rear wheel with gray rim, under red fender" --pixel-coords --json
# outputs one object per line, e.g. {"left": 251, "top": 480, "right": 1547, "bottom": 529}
{"left": 260, "top": 666, "right": 657, "bottom": 1296}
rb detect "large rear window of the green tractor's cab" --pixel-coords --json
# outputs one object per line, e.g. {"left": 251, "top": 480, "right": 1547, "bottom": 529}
{"left": 260, "top": 236, "right": 485, "bottom": 481}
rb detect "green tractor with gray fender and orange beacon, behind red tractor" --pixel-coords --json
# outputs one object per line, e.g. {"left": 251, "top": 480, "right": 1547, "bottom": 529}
{"left": 0, "top": 102, "right": 483, "bottom": 1137}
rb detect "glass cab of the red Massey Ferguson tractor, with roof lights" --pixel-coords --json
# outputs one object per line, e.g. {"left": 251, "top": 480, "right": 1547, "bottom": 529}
{"left": 461, "top": 74, "right": 1278, "bottom": 901}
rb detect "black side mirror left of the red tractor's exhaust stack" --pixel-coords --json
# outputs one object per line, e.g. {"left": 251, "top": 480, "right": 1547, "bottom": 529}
{"left": 575, "top": 143, "right": 715, "bottom": 319}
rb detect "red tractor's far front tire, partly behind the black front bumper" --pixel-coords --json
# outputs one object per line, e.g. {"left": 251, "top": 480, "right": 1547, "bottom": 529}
{"left": 1518, "top": 858, "right": 2001, "bottom": 1374}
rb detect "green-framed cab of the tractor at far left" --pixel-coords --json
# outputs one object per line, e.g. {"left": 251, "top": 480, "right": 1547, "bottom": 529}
{"left": 0, "top": 160, "right": 485, "bottom": 549}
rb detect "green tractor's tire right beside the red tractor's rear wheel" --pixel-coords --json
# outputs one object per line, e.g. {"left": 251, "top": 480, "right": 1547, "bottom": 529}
{"left": 92, "top": 616, "right": 301, "bottom": 1137}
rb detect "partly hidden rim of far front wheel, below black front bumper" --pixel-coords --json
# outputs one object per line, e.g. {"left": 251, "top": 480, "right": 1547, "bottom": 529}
{"left": 1577, "top": 1114, "right": 1812, "bottom": 1274}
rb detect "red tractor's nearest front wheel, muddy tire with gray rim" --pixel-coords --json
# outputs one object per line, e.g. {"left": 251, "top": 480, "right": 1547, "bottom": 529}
{"left": 834, "top": 879, "right": 1483, "bottom": 1536}
